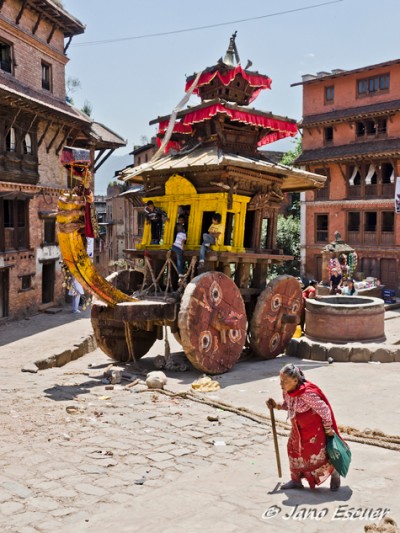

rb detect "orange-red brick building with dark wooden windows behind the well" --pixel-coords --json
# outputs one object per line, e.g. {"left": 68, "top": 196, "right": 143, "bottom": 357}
{"left": 293, "top": 59, "right": 400, "bottom": 291}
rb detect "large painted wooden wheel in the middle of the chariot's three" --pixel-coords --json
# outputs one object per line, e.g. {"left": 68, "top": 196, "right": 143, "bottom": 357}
{"left": 178, "top": 272, "right": 247, "bottom": 374}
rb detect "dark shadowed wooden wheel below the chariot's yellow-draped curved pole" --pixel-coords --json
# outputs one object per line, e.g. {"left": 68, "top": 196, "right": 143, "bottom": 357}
{"left": 91, "top": 301, "right": 157, "bottom": 363}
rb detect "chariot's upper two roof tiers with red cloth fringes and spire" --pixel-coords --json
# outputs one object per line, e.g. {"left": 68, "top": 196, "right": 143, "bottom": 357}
{"left": 150, "top": 33, "right": 298, "bottom": 155}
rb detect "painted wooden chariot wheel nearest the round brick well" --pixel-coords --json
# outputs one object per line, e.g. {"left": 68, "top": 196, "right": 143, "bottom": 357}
{"left": 250, "top": 275, "right": 302, "bottom": 359}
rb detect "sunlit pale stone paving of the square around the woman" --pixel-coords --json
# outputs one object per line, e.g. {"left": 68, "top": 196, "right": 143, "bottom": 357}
{"left": 0, "top": 310, "right": 400, "bottom": 533}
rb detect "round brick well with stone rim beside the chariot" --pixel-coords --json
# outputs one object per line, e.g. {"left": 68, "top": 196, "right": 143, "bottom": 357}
{"left": 305, "top": 296, "right": 386, "bottom": 344}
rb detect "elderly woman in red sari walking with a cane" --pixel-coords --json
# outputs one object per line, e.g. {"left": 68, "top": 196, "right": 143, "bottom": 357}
{"left": 266, "top": 364, "right": 340, "bottom": 491}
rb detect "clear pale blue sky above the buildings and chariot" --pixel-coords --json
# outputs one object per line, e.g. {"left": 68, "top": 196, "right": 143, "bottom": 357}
{"left": 63, "top": 0, "right": 400, "bottom": 155}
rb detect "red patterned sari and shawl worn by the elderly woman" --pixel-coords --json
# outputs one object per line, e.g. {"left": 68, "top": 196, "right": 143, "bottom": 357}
{"left": 282, "top": 381, "right": 339, "bottom": 488}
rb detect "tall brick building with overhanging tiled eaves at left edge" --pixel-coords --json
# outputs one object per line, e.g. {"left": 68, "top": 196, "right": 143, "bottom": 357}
{"left": 0, "top": 0, "right": 126, "bottom": 320}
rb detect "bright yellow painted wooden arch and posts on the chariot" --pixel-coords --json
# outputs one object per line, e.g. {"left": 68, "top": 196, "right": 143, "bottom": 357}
{"left": 136, "top": 174, "right": 250, "bottom": 252}
